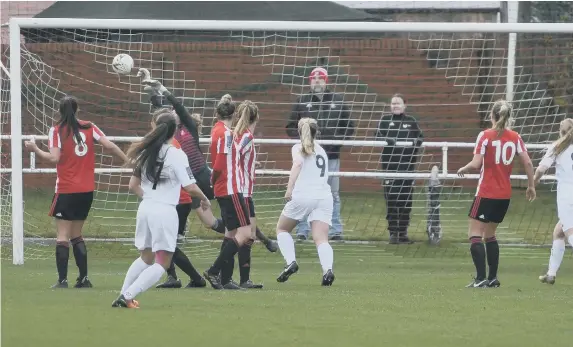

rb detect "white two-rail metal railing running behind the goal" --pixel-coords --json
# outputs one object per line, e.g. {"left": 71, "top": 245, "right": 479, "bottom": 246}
{"left": 0, "top": 135, "right": 555, "bottom": 180}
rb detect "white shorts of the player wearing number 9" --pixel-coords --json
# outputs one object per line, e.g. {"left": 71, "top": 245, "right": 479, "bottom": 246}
{"left": 282, "top": 195, "right": 333, "bottom": 226}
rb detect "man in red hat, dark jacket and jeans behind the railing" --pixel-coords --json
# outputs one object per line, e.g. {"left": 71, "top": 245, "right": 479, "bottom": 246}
{"left": 286, "top": 67, "right": 354, "bottom": 240}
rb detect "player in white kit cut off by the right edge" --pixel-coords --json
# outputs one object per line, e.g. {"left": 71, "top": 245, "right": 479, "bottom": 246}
{"left": 535, "top": 118, "right": 573, "bottom": 284}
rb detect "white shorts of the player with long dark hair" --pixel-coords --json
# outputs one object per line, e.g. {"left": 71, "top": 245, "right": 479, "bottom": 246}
{"left": 135, "top": 200, "right": 179, "bottom": 252}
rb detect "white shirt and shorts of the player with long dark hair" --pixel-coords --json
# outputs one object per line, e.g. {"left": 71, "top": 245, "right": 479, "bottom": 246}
{"left": 135, "top": 145, "right": 195, "bottom": 252}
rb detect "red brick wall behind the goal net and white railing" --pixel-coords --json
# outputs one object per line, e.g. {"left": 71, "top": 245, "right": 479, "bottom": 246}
{"left": 3, "top": 39, "right": 479, "bottom": 190}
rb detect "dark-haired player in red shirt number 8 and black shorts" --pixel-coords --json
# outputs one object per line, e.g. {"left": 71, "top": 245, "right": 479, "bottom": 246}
{"left": 25, "top": 96, "right": 126, "bottom": 288}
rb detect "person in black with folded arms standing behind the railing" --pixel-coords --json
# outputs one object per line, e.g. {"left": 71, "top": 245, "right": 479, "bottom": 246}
{"left": 376, "top": 94, "right": 424, "bottom": 244}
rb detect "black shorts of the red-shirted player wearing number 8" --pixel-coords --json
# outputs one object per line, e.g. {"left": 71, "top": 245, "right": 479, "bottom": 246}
{"left": 48, "top": 192, "right": 94, "bottom": 221}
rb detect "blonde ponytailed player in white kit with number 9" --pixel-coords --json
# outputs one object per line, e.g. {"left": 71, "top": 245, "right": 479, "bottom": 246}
{"left": 277, "top": 118, "right": 334, "bottom": 286}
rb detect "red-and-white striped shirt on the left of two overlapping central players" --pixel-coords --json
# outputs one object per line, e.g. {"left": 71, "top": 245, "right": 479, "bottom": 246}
{"left": 209, "top": 121, "right": 244, "bottom": 197}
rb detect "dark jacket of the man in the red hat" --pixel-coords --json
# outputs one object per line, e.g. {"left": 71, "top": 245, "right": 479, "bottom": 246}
{"left": 286, "top": 89, "right": 354, "bottom": 159}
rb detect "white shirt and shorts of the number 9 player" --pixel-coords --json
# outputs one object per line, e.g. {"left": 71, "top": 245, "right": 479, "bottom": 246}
{"left": 282, "top": 144, "right": 333, "bottom": 225}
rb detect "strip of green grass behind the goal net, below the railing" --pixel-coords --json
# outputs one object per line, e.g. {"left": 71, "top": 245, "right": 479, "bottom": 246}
{"left": 20, "top": 187, "right": 556, "bottom": 244}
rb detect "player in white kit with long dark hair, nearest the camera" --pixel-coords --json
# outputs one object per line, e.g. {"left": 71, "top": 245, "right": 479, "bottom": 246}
{"left": 112, "top": 113, "right": 211, "bottom": 308}
